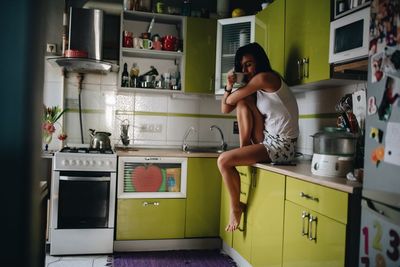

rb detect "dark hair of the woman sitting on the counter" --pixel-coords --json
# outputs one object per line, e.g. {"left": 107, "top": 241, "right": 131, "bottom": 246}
{"left": 235, "top": 42, "right": 275, "bottom": 73}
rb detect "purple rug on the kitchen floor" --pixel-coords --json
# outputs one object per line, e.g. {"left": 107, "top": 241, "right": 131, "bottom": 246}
{"left": 113, "top": 250, "right": 237, "bottom": 267}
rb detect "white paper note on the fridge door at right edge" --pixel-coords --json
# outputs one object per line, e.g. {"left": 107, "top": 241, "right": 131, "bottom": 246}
{"left": 384, "top": 122, "right": 400, "bottom": 165}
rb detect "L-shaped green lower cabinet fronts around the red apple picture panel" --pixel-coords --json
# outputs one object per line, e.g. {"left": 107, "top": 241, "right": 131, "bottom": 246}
{"left": 116, "top": 158, "right": 221, "bottom": 240}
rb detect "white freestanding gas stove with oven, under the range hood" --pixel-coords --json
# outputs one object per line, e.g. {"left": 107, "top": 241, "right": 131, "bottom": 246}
{"left": 50, "top": 149, "right": 117, "bottom": 255}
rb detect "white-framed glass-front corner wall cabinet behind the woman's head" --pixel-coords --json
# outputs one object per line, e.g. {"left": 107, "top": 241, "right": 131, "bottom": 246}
{"left": 215, "top": 16, "right": 255, "bottom": 95}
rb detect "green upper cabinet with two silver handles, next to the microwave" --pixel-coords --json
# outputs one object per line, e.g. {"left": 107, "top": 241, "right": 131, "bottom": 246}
{"left": 284, "top": 0, "right": 331, "bottom": 86}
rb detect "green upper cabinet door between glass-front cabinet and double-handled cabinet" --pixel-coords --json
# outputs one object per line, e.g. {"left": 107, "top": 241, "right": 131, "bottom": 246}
{"left": 255, "top": 0, "right": 285, "bottom": 76}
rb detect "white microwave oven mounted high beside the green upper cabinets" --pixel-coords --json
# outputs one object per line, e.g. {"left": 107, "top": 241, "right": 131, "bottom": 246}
{"left": 329, "top": 7, "right": 370, "bottom": 64}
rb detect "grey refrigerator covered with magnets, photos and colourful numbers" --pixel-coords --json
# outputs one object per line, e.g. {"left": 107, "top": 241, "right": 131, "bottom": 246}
{"left": 359, "top": 0, "right": 400, "bottom": 267}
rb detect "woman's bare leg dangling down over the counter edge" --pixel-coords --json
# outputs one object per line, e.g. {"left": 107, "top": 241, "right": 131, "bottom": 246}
{"left": 218, "top": 144, "right": 269, "bottom": 232}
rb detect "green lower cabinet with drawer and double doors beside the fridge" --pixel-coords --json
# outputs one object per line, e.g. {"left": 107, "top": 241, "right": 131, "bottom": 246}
{"left": 282, "top": 177, "right": 348, "bottom": 267}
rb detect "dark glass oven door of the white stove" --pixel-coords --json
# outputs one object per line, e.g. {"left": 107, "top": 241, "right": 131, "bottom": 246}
{"left": 52, "top": 171, "right": 116, "bottom": 229}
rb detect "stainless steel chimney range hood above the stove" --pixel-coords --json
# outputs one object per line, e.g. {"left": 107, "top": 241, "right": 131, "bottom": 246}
{"left": 47, "top": 7, "right": 119, "bottom": 74}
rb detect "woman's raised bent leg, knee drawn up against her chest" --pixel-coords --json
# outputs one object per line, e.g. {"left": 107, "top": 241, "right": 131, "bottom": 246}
{"left": 236, "top": 94, "right": 264, "bottom": 147}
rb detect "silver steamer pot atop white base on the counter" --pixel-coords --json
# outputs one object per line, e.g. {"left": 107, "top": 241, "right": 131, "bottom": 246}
{"left": 312, "top": 127, "right": 357, "bottom": 157}
